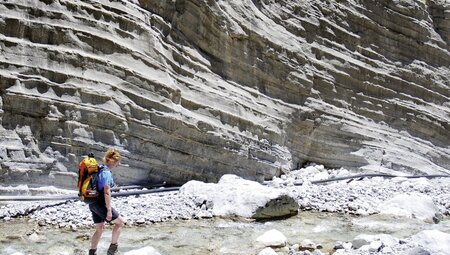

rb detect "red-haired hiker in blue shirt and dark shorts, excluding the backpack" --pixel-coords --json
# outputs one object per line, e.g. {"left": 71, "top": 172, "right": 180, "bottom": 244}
{"left": 89, "top": 148, "right": 124, "bottom": 255}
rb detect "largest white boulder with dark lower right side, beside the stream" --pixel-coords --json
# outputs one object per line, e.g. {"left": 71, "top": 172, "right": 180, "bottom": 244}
{"left": 180, "top": 175, "right": 299, "bottom": 220}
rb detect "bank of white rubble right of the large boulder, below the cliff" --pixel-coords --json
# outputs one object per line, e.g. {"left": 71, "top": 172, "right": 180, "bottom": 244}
{"left": 267, "top": 165, "right": 450, "bottom": 217}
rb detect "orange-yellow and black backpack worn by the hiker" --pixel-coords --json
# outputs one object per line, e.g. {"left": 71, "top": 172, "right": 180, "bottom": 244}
{"left": 77, "top": 153, "right": 102, "bottom": 204}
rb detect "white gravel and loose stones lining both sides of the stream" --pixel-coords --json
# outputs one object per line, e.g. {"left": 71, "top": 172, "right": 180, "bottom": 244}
{"left": 0, "top": 166, "right": 450, "bottom": 255}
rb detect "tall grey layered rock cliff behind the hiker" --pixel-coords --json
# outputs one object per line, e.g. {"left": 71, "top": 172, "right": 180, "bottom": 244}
{"left": 0, "top": 0, "right": 450, "bottom": 186}
